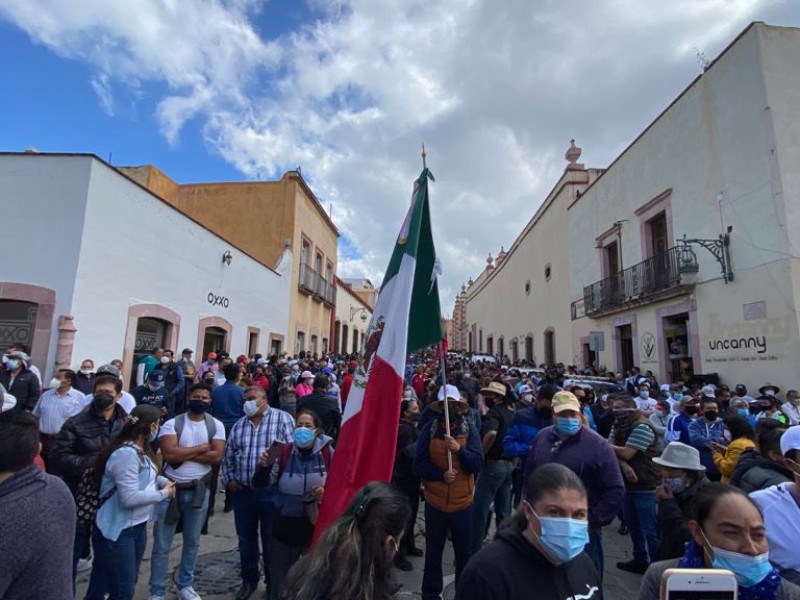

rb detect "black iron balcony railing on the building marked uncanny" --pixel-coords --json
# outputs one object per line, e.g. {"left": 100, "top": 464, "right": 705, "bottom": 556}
{"left": 572, "top": 246, "right": 692, "bottom": 319}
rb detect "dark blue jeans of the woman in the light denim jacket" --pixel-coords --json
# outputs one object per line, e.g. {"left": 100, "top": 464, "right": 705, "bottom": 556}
{"left": 85, "top": 522, "right": 147, "bottom": 600}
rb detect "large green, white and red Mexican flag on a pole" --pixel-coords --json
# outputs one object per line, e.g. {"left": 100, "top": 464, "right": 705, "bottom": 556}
{"left": 314, "top": 168, "right": 444, "bottom": 540}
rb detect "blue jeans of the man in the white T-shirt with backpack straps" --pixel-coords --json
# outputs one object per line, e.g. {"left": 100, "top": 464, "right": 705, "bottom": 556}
{"left": 150, "top": 489, "right": 209, "bottom": 596}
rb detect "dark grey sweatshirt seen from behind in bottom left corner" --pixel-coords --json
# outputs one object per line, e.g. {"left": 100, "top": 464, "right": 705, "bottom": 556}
{"left": 0, "top": 465, "right": 75, "bottom": 600}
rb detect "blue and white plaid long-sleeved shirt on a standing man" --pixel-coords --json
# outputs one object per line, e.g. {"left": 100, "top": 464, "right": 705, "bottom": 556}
{"left": 222, "top": 408, "right": 294, "bottom": 486}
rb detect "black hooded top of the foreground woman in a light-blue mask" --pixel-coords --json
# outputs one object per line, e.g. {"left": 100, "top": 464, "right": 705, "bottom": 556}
{"left": 456, "top": 524, "right": 603, "bottom": 600}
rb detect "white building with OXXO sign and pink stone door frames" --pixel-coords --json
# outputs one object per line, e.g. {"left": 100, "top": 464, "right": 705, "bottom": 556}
{"left": 0, "top": 153, "right": 291, "bottom": 381}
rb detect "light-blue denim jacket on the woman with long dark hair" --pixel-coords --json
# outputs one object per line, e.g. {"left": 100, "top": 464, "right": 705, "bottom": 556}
{"left": 96, "top": 445, "right": 169, "bottom": 542}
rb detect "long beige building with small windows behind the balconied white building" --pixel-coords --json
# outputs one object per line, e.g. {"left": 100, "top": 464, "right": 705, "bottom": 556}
{"left": 458, "top": 143, "right": 599, "bottom": 364}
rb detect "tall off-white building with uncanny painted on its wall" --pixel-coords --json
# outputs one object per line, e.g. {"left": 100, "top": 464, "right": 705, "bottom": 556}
{"left": 569, "top": 24, "right": 800, "bottom": 390}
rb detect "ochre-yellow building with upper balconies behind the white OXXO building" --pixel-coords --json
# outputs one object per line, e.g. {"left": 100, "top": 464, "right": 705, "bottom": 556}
{"left": 119, "top": 165, "right": 339, "bottom": 354}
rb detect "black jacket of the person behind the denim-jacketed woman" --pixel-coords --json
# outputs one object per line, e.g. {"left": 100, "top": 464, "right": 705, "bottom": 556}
{"left": 50, "top": 404, "right": 126, "bottom": 493}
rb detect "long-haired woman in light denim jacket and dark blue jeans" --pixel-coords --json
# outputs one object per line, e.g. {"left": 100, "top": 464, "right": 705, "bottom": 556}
{"left": 86, "top": 404, "right": 175, "bottom": 600}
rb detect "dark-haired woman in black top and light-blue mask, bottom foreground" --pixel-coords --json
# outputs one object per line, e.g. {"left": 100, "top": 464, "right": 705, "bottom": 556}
{"left": 456, "top": 463, "right": 603, "bottom": 600}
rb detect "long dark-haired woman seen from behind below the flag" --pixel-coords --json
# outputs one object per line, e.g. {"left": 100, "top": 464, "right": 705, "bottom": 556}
{"left": 281, "top": 481, "right": 409, "bottom": 600}
